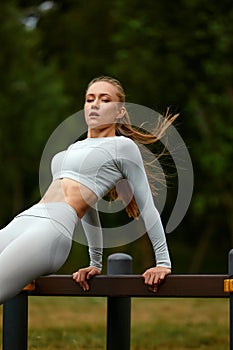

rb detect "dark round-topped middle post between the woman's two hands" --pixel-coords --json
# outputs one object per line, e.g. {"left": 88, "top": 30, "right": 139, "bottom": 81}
{"left": 107, "top": 253, "right": 132, "bottom": 350}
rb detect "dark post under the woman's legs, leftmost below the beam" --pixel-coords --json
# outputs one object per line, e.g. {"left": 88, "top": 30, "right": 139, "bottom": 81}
{"left": 2, "top": 292, "right": 28, "bottom": 350}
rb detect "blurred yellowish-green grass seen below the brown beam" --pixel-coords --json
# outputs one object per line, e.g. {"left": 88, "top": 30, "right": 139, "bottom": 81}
{"left": 0, "top": 297, "right": 229, "bottom": 350}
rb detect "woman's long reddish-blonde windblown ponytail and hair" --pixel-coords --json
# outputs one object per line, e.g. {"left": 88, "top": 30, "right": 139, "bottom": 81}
{"left": 87, "top": 76, "right": 178, "bottom": 219}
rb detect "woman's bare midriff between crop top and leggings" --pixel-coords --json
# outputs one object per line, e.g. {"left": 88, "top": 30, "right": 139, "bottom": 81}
{"left": 40, "top": 178, "right": 97, "bottom": 218}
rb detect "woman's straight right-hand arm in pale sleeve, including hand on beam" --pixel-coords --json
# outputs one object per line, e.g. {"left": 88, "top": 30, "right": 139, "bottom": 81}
{"left": 119, "top": 141, "right": 171, "bottom": 291}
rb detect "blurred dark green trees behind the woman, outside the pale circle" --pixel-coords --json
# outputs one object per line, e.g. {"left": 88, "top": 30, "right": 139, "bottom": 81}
{"left": 0, "top": 0, "right": 233, "bottom": 273}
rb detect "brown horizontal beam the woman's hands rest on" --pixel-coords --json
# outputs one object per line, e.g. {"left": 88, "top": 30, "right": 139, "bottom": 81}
{"left": 29, "top": 275, "right": 229, "bottom": 298}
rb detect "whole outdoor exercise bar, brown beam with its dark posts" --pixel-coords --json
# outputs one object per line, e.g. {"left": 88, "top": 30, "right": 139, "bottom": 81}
{"left": 2, "top": 254, "right": 228, "bottom": 350}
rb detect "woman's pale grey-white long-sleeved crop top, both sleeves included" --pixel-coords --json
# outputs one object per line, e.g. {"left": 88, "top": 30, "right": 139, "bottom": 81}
{"left": 51, "top": 136, "right": 171, "bottom": 269}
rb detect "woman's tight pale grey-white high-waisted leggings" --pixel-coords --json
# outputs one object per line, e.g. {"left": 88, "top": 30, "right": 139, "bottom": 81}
{"left": 0, "top": 202, "right": 78, "bottom": 304}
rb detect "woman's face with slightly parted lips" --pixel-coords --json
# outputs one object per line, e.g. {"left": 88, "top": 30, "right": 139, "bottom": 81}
{"left": 84, "top": 81, "right": 125, "bottom": 134}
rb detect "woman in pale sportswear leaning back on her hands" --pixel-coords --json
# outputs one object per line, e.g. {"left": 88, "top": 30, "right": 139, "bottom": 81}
{"left": 0, "top": 77, "right": 175, "bottom": 303}
